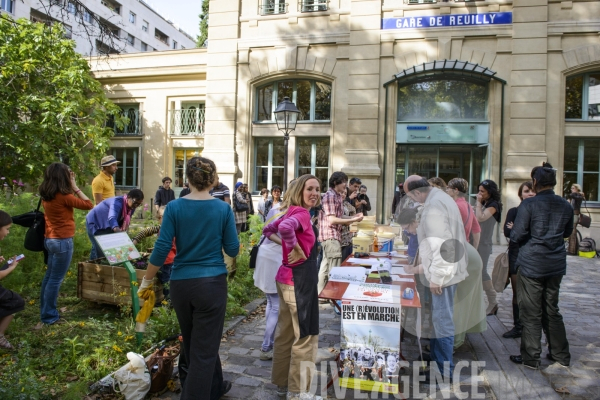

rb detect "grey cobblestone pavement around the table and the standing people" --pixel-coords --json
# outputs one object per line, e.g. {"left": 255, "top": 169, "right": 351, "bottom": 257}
{"left": 156, "top": 246, "right": 600, "bottom": 400}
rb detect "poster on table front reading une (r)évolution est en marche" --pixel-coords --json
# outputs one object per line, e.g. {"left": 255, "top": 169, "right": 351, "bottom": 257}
{"left": 338, "top": 300, "right": 402, "bottom": 393}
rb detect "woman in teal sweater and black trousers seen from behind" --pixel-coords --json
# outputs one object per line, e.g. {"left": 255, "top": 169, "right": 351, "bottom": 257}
{"left": 140, "top": 157, "right": 240, "bottom": 400}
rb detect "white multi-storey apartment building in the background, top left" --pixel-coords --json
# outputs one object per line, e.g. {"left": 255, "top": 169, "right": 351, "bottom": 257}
{"left": 0, "top": 0, "right": 196, "bottom": 55}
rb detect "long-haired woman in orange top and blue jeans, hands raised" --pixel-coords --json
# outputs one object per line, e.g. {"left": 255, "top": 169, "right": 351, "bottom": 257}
{"left": 35, "top": 163, "right": 94, "bottom": 329}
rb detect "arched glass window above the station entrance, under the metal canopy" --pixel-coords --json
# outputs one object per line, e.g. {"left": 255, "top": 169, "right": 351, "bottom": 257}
{"left": 398, "top": 79, "right": 487, "bottom": 122}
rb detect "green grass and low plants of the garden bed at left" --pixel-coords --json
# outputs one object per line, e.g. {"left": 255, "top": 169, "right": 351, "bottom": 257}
{"left": 0, "top": 193, "right": 262, "bottom": 400}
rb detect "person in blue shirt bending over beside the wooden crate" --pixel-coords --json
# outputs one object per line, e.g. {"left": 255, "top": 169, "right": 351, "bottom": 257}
{"left": 85, "top": 189, "right": 144, "bottom": 260}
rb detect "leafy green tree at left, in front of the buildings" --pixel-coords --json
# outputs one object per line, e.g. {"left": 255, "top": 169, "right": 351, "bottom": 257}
{"left": 0, "top": 16, "right": 126, "bottom": 183}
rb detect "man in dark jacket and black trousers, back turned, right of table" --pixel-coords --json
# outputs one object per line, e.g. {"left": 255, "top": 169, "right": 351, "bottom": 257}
{"left": 510, "top": 163, "right": 573, "bottom": 369}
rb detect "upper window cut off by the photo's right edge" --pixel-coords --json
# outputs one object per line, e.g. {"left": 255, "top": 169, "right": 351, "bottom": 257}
{"left": 565, "top": 71, "right": 600, "bottom": 121}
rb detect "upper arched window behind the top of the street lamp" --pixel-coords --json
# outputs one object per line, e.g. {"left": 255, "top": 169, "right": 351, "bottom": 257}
{"left": 254, "top": 79, "right": 331, "bottom": 122}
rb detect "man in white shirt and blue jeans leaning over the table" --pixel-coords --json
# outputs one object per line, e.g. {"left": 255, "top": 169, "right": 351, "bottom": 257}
{"left": 404, "top": 175, "right": 468, "bottom": 383}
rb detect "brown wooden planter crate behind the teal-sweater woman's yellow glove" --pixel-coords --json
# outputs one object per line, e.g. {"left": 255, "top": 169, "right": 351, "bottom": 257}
{"left": 77, "top": 262, "right": 164, "bottom": 307}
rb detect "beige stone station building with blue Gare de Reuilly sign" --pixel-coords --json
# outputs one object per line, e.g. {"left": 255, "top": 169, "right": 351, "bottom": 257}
{"left": 90, "top": 0, "right": 600, "bottom": 236}
